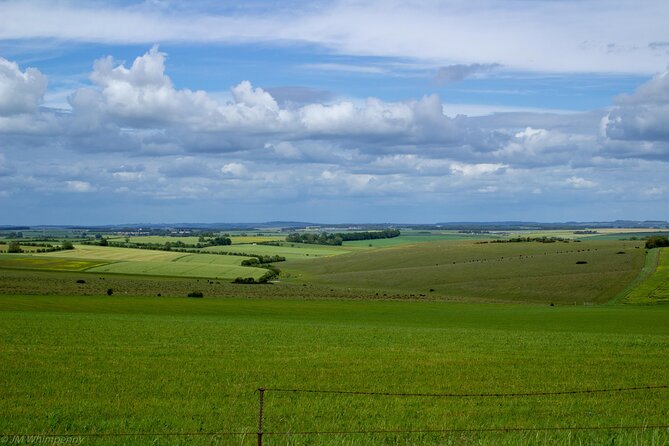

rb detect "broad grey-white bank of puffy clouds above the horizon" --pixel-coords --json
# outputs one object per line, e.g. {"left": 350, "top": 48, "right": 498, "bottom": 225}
{"left": 0, "top": 47, "right": 669, "bottom": 221}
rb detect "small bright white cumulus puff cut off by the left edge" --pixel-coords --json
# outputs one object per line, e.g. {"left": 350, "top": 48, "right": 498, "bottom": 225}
{"left": 0, "top": 57, "right": 47, "bottom": 116}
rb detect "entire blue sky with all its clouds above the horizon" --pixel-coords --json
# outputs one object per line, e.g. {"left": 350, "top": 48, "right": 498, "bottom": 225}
{"left": 0, "top": 0, "right": 669, "bottom": 225}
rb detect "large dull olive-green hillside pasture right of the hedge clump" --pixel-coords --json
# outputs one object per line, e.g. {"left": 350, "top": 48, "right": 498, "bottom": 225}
{"left": 282, "top": 241, "right": 644, "bottom": 304}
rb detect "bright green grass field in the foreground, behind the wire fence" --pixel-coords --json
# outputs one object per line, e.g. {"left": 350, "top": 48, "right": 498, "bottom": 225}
{"left": 0, "top": 296, "right": 669, "bottom": 445}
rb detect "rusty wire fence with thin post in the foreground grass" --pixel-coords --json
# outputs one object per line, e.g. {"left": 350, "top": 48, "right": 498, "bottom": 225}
{"left": 0, "top": 384, "right": 669, "bottom": 446}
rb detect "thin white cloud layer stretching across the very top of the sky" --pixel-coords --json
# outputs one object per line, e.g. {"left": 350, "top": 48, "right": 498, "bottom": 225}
{"left": 0, "top": 0, "right": 669, "bottom": 74}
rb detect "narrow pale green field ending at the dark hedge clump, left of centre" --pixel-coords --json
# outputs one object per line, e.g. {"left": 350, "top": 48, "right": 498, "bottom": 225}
{"left": 88, "top": 256, "right": 267, "bottom": 280}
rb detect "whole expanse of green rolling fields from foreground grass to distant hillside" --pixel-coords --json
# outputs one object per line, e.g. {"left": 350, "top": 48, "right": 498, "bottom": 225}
{"left": 0, "top": 231, "right": 669, "bottom": 445}
